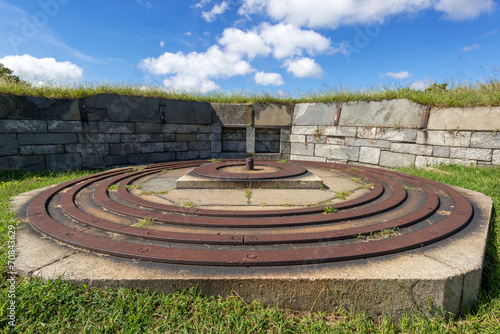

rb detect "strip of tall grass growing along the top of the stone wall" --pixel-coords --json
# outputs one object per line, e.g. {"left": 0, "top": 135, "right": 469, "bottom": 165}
{"left": 0, "top": 78, "right": 500, "bottom": 107}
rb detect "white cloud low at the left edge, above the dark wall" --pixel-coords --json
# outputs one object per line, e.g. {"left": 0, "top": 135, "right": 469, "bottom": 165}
{"left": 0, "top": 54, "right": 83, "bottom": 81}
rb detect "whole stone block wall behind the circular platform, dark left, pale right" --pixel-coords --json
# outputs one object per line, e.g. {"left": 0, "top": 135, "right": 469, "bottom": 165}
{"left": 0, "top": 94, "right": 500, "bottom": 170}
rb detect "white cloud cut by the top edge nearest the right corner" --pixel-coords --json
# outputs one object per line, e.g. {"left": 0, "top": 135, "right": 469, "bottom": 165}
{"left": 434, "top": 0, "right": 495, "bottom": 21}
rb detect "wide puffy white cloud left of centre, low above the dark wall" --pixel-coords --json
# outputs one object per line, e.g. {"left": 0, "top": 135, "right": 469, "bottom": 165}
{"left": 139, "top": 45, "right": 254, "bottom": 92}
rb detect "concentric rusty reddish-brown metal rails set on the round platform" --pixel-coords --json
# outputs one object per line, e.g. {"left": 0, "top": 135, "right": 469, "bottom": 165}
{"left": 27, "top": 161, "right": 474, "bottom": 267}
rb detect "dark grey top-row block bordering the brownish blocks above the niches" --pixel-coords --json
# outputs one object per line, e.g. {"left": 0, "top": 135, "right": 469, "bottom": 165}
{"left": 165, "top": 100, "right": 212, "bottom": 124}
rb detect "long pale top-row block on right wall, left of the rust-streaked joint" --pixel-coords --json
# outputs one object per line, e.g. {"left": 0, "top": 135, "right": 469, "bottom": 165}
{"left": 339, "top": 99, "right": 423, "bottom": 128}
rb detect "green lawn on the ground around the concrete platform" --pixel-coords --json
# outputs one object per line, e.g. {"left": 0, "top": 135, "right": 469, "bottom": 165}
{"left": 0, "top": 166, "right": 500, "bottom": 333}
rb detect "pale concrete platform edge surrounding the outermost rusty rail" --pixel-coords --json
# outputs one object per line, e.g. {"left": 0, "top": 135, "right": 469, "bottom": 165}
{"left": 12, "top": 187, "right": 492, "bottom": 319}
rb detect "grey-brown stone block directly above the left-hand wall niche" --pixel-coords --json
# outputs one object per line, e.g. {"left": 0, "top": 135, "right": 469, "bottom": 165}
{"left": 211, "top": 103, "right": 253, "bottom": 127}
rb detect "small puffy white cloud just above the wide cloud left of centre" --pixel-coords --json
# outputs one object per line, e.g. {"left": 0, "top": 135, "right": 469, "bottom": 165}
{"left": 219, "top": 28, "right": 271, "bottom": 59}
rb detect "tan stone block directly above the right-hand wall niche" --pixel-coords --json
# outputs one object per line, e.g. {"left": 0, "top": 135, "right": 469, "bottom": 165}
{"left": 252, "top": 103, "right": 293, "bottom": 126}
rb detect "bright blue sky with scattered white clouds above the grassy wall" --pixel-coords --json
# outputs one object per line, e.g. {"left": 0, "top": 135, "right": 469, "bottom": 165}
{"left": 0, "top": 0, "right": 500, "bottom": 95}
